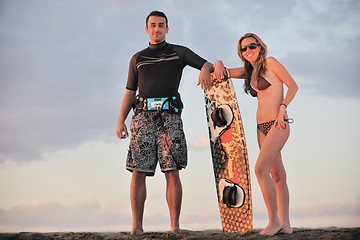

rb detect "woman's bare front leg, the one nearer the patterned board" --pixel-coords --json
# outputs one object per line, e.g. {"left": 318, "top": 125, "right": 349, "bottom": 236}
{"left": 255, "top": 125, "right": 290, "bottom": 235}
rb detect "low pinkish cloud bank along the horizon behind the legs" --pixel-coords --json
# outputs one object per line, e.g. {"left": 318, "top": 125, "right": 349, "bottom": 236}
{"left": 0, "top": 201, "right": 360, "bottom": 232}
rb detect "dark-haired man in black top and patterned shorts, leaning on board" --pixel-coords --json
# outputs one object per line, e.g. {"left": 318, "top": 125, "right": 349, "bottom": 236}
{"left": 116, "top": 11, "right": 213, "bottom": 234}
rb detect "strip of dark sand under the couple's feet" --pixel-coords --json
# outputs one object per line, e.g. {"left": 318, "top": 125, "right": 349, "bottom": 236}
{"left": 0, "top": 227, "right": 360, "bottom": 240}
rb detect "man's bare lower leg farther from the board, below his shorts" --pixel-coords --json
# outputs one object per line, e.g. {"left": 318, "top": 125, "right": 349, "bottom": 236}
{"left": 130, "top": 171, "right": 146, "bottom": 235}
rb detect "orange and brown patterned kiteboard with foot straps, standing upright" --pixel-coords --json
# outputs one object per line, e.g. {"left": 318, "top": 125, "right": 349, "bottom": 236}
{"left": 204, "top": 74, "right": 253, "bottom": 233}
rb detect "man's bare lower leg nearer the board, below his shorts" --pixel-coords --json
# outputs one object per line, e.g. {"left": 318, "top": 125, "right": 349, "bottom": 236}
{"left": 165, "top": 170, "right": 182, "bottom": 233}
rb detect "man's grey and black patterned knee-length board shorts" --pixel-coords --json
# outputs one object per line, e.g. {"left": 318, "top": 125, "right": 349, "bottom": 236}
{"left": 126, "top": 111, "right": 187, "bottom": 176}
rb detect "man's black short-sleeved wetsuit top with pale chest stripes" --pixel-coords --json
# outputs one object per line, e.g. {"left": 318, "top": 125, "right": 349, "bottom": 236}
{"left": 126, "top": 41, "right": 206, "bottom": 98}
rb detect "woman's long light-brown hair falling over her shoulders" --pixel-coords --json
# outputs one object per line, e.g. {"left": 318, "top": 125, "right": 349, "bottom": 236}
{"left": 237, "top": 33, "right": 267, "bottom": 93}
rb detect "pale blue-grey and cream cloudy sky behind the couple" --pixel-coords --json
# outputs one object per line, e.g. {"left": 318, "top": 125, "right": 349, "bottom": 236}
{"left": 0, "top": 0, "right": 360, "bottom": 232}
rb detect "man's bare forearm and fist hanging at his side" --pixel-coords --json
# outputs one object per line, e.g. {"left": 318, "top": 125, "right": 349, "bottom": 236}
{"left": 116, "top": 89, "right": 136, "bottom": 139}
